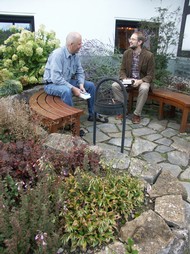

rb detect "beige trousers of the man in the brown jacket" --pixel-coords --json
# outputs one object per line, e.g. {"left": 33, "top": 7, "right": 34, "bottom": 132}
{"left": 112, "top": 82, "right": 150, "bottom": 116}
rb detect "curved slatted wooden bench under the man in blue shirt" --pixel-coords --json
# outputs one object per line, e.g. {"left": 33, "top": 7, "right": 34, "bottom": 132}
{"left": 29, "top": 89, "right": 84, "bottom": 136}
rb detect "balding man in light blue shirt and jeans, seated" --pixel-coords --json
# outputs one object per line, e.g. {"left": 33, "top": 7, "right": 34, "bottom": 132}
{"left": 44, "top": 32, "right": 108, "bottom": 123}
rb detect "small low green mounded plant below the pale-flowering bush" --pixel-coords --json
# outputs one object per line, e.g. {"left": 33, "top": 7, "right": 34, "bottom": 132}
{"left": 0, "top": 79, "right": 23, "bottom": 97}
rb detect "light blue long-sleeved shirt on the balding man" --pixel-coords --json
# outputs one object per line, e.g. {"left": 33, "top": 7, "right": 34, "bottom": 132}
{"left": 43, "top": 47, "right": 85, "bottom": 88}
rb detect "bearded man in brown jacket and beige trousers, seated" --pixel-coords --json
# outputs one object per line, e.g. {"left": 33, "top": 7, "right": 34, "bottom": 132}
{"left": 112, "top": 32, "right": 155, "bottom": 124}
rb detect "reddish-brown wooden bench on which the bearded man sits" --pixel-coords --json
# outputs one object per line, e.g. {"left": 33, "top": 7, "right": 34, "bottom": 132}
{"left": 128, "top": 88, "right": 190, "bottom": 132}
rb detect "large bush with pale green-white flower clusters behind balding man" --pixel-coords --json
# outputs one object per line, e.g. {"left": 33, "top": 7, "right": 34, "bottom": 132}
{"left": 0, "top": 26, "right": 59, "bottom": 86}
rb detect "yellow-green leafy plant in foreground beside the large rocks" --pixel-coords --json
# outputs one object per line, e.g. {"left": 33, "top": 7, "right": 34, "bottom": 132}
{"left": 61, "top": 172, "right": 143, "bottom": 250}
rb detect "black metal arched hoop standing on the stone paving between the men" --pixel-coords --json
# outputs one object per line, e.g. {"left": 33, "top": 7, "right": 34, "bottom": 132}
{"left": 93, "top": 78, "right": 127, "bottom": 153}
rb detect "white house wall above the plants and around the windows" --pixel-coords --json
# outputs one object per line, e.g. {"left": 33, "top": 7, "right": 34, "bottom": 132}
{"left": 0, "top": 0, "right": 184, "bottom": 53}
